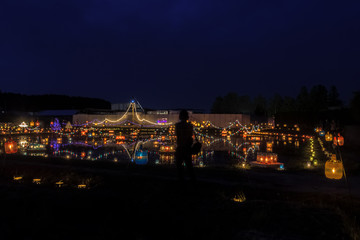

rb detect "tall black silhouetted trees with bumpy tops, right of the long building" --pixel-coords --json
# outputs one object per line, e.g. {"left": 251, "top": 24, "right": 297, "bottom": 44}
{"left": 211, "top": 85, "right": 360, "bottom": 124}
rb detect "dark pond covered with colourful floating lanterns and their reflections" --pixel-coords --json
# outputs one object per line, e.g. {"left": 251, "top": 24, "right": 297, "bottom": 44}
{"left": 0, "top": 132, "right": 320, "bottom": 170}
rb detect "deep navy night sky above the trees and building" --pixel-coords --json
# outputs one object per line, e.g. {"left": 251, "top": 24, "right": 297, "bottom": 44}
{"left": 0, "top": 0, "right": 360, "bottom": 110}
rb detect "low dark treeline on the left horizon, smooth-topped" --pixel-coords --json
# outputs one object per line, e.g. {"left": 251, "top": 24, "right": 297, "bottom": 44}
{"left": 0, "top": 92, "right": 111, "bottom": 112}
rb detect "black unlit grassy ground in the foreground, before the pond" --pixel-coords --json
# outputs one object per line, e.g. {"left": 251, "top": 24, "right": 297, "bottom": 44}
{"left": 0, "top": 157, "right": 360, "bottom": 239}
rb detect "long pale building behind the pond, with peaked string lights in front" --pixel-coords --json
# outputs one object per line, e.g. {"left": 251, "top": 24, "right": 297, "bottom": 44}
{"left": 73, "top": 101, "right": 257, "bottom": 132}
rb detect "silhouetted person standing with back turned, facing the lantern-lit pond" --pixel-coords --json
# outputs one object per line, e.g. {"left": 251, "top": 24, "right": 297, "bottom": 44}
{"left": 175, "top": 110, "right": 195, "bottom": 181}
